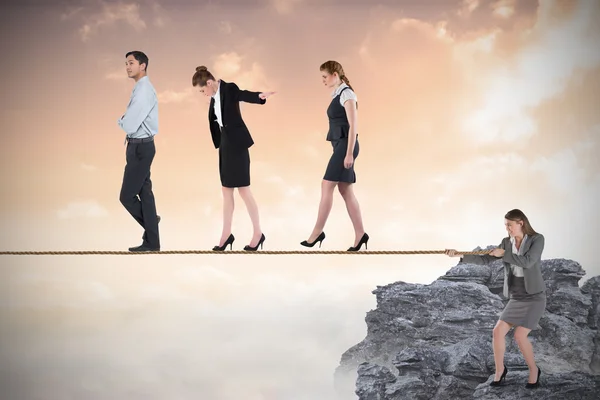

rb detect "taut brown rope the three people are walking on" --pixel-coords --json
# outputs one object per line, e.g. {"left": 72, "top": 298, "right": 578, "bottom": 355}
{"left": 0, "top": 250, "right": 491, "bottom": 256}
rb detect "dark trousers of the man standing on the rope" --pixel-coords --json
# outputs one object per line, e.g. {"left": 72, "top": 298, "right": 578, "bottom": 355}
{"left": 119, "top": 139, "right": 160, "bottom": 249}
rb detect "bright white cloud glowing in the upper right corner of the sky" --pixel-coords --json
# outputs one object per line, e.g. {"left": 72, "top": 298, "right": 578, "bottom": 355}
{"left": 464, "top": 2, "right": 600, "bottom": 143}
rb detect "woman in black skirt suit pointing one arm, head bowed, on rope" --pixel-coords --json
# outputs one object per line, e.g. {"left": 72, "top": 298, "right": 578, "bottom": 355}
{"left": 192, "top": 66, "right": 275, "bottom": 251}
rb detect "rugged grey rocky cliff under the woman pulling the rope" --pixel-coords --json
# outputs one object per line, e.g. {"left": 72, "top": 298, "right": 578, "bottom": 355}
{"left": 335, "top": 248, "right": 600, "bottom": 400}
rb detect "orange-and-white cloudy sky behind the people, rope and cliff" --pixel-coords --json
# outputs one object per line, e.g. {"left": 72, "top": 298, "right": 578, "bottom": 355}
{"left": 0, "top": 0, "right": 600, "bottom": 400}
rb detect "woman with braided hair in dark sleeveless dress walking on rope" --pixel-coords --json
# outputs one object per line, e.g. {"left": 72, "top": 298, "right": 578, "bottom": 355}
{"left": 300, "top": 61, "right": 369, "bottom": 251}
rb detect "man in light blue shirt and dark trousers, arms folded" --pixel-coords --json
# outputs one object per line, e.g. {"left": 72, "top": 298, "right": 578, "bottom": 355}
{"left": 118, "top": 51, "right": 160, "bottom": 251}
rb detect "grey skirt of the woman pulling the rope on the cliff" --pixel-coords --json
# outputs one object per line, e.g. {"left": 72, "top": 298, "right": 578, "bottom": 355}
{"left": 500, "top": 276, "right": 546, "bottom": 330}
